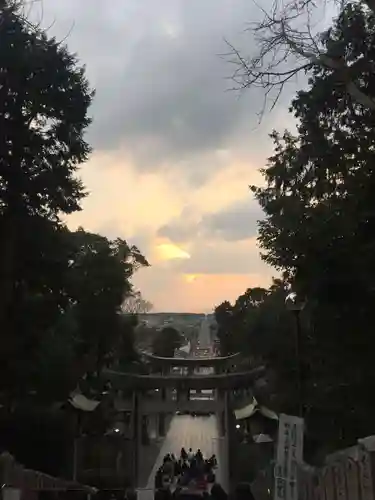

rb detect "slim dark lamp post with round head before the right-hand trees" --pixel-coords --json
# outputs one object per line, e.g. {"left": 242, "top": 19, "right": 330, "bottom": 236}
{"left": 285, "top": 292, "right": 305, "bottom": 417}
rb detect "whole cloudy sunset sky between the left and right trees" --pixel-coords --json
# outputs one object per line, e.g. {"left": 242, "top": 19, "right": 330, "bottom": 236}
{"left": 32, "top": 0, "right": 300, "bottom": 312}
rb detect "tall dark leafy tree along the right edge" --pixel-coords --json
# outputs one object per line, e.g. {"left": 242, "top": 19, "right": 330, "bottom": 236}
{"left": 238, "top": 4, "right": 375, "bottom": 452}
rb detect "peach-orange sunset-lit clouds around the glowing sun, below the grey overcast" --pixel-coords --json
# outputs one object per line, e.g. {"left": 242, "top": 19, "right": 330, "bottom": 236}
{"left": 64, "top": 151, "right": 274, "bottom": 312}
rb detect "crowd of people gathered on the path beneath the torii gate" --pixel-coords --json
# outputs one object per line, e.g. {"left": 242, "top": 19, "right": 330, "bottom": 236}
{"left": 155, "top": 448, "right": 220, "bottom": 500}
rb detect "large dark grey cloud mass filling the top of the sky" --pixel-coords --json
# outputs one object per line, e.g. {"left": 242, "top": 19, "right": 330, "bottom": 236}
{"left": 37, "top": 0, "right": 284, "bottom": 182}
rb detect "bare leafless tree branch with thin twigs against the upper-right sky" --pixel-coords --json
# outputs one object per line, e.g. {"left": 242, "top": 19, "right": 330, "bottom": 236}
{"left": 226, "top": 0, "right": 375, "bottom": 116}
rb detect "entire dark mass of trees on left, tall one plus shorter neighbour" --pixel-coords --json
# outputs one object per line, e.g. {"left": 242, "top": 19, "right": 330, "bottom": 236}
{"left": 0, "top": 1, "right": 148, "bottom": 408}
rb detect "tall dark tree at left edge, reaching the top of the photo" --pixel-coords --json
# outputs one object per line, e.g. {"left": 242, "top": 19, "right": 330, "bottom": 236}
{"left": 0, "top": 3, "right": 93, "bottom": 385}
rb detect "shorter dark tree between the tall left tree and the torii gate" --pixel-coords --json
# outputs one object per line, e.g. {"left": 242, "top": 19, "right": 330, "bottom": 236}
{"left": 30, "top": 228, "right": 147, "bottom": 398}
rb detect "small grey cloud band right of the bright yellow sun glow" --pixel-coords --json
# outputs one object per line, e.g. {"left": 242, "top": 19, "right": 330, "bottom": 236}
{"left": 158, "top": 197, "right": 263, "bottom": 243}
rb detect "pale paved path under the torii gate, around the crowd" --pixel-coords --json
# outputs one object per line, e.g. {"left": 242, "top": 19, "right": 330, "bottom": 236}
{"left": 138, "top": 415, "right": 226, "bottom": 500}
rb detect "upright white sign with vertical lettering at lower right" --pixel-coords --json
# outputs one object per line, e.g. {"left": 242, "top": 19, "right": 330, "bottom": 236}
{"left": 274, "top": 413, "right": 303, "bottom": 500}
